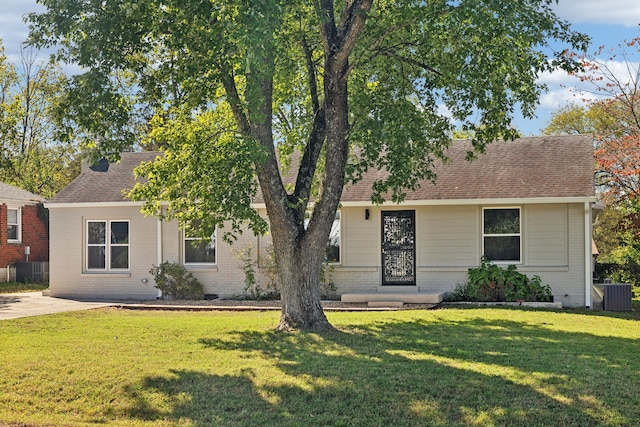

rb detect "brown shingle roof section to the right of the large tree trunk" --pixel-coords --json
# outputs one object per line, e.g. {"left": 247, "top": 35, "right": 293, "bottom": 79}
{"left": 342, "top": 135, "right": 595, "bottom": 202}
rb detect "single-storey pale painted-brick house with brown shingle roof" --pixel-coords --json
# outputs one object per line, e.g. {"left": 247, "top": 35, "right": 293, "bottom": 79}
{"left": 46, "top": 136, "right": 595, "bottom": 306}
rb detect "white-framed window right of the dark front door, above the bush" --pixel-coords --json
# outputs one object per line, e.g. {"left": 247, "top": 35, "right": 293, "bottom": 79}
{"left": 482, "top": 208, "right": 521, "bottom": 262}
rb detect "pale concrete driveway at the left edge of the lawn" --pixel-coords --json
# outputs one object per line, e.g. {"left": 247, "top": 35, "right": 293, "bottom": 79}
{"left": 0, "top": 292, "right": 114, "bottom": 320}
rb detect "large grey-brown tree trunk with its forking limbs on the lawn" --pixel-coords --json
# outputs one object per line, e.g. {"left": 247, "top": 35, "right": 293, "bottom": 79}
{"left": 241, "top": 0, "right": 373, "bottom": 331}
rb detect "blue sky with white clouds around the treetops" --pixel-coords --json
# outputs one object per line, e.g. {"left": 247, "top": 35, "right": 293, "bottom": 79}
{"left": 0, "top": 0, "right": 640, "bottom": 136}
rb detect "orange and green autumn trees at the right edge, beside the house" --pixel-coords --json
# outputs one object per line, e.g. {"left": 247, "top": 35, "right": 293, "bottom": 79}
{"left": 543, "top": 38, "right": 640, "bottom": 270}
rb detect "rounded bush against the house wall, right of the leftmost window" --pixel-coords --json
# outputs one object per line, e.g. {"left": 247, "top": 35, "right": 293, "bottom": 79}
{"left": 149, "top": 261, "right": 204, "bottom": 300}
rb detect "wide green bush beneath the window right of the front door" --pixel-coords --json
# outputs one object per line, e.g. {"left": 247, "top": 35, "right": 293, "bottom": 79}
{"left": 449, "top": 257, "right": 553, "bottom": 302}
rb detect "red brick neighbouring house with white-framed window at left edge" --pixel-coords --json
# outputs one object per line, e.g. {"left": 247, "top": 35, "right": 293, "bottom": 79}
{"left": 0, "top": 182, "right": 49, "bottom": 282}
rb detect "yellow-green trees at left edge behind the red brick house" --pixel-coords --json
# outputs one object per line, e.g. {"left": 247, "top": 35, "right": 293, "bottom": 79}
{"left": 0, "top": 41, "right": 78, "bottom": 197}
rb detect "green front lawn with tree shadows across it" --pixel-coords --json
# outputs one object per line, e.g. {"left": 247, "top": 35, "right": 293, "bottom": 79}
{"left": 0, "top": 308, "right": 640, "bottom": 426}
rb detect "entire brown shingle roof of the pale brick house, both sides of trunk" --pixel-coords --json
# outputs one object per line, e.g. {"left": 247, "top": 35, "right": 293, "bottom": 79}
{"left": 50, "top": 135, "right": 595, "bottom": 203}
